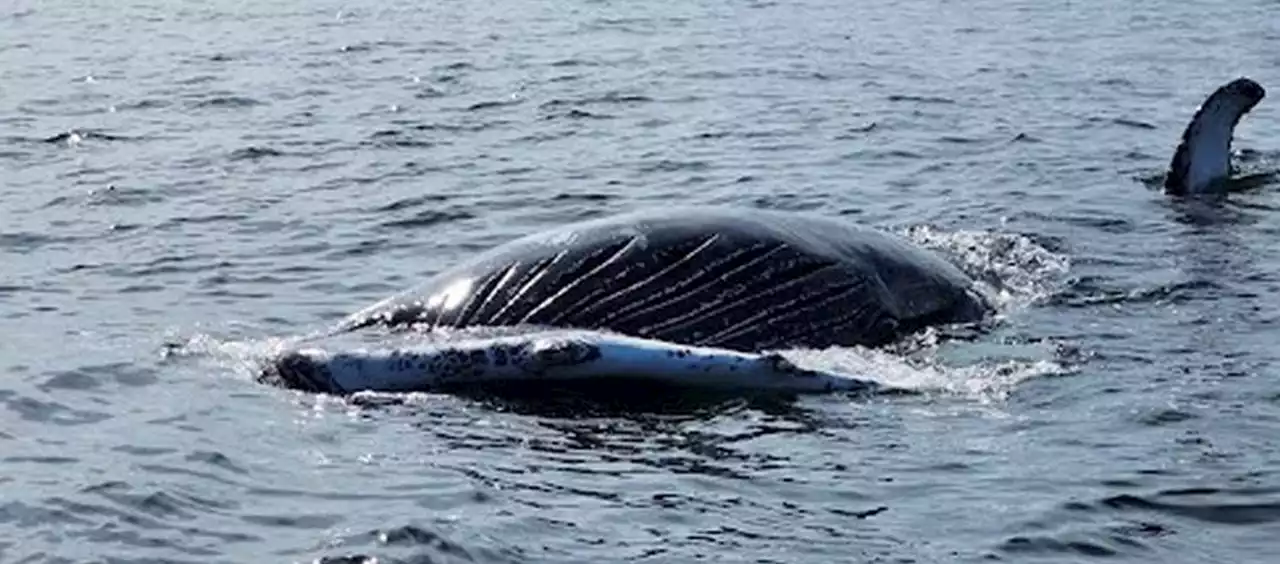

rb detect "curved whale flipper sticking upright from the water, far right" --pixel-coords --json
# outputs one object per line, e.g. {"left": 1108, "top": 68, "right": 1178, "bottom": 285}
{"left": 1165, "top": 77, "right": 1267, "bottom": 196}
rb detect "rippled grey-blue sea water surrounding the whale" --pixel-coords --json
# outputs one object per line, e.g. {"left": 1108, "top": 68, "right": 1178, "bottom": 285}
{"left": 0, "top": 0, "right": 1280, "bottom": 563}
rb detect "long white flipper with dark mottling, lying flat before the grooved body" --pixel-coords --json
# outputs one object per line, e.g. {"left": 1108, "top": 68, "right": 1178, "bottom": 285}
{"left": 257, "top": 331, "right": 877, "bottom": 395}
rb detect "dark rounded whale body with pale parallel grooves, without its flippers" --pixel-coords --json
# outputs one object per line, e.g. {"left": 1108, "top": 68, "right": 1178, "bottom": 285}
{"left": 342, "top": 208, "right": 987, "bottom": 350}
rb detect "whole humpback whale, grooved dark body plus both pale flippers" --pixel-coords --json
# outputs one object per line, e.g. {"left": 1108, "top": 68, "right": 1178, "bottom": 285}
{"left": 259, "top": 78, "right": 1265, "bottom": 394}
